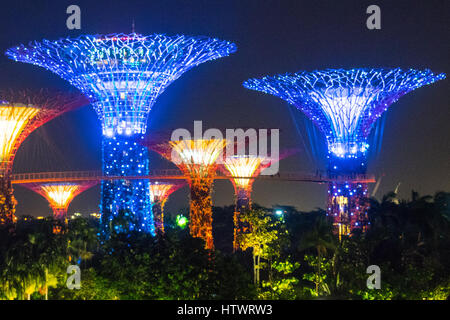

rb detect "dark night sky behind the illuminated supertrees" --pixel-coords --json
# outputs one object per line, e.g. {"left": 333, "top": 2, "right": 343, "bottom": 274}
{"left": 0, "top": 0, "right": 450, "bottom": 219}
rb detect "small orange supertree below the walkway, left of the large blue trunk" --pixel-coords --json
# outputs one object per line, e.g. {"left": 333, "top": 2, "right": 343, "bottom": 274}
{"left": 20, "top": 181, "right": 98, "bottom": 223}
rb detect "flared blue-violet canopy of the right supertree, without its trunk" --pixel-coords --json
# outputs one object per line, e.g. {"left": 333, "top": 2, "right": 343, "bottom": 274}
{"left": 244, "top": 68, "right": 445, "bottom": 161}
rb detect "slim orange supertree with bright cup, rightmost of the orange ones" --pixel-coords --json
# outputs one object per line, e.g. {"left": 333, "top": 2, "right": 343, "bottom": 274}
{"left": 221, "top": 155, "right": 271, "bottom": 251}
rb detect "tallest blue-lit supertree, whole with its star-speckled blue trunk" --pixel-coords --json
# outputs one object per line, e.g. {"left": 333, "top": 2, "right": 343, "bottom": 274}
{"left": 6, "top": 33, "right": 236, "bottom": 237}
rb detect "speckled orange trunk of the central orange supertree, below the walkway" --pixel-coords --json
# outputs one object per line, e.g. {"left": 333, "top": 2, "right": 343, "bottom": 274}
{"left": 189, "top": 179, "right": 214, "bottom": 250}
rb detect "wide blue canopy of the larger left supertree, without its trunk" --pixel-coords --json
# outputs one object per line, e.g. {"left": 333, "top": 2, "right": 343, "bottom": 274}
{"left": 6, "top": 33, "right": 236, "bottom": 136}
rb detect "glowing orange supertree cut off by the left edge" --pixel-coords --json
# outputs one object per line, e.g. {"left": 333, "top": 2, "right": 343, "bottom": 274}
{"left": 0, "top": 89, "right": 89, "bottom": 224}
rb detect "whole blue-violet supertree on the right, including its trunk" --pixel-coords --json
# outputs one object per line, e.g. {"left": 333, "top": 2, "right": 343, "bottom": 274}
{"left": 244, "top": 68, "right": 445, "bottom": 235}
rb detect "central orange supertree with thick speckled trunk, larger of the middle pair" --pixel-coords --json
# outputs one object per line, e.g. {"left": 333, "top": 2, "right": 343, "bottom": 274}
{"left": 150, "top": 139, "right": 227, "bottom": 250}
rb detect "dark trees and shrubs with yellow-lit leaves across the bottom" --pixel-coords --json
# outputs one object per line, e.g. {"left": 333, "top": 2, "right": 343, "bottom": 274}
{"left": 0, "top": 192, "right": 450, "bottom": 300}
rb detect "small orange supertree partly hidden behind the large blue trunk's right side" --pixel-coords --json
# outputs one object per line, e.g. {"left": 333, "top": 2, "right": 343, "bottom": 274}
{"left": 150, "top": 181, "right": 184, "bottom": 235}
